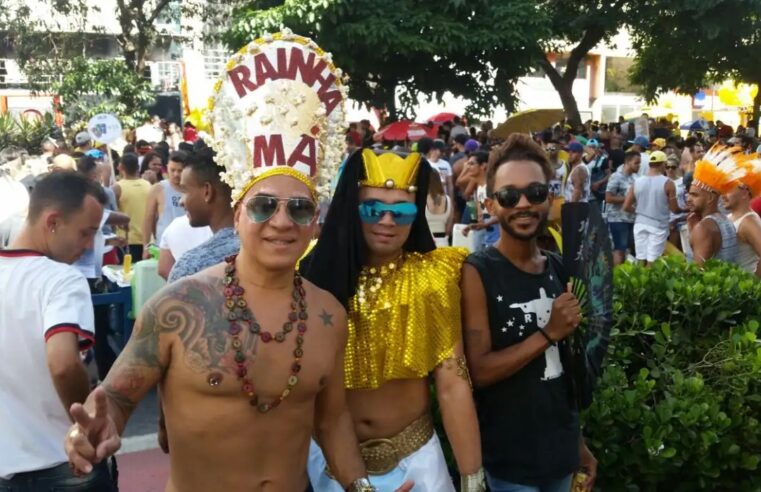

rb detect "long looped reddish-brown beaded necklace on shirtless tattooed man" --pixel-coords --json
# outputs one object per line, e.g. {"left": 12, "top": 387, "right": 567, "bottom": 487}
{"left": 223, "top": 255, "right": 308, "bottom": 413}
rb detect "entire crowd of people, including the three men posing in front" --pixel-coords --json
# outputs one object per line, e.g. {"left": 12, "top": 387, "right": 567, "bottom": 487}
{"left": 0, "top": 33, "right": 761, "bottom": 492}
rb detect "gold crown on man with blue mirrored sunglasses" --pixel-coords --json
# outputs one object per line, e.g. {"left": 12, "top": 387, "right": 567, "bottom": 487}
{"left": 360, "top": 149, "right": 421, "bottom": 193}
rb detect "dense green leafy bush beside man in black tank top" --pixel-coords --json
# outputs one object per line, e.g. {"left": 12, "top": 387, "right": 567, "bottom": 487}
{"left": 583, "top": 258, "right": 761, "bottom": 492}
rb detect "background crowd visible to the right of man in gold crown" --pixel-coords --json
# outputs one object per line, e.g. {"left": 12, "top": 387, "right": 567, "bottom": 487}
{"left": 410, "top": 115, "right": 761, "bottom": 275}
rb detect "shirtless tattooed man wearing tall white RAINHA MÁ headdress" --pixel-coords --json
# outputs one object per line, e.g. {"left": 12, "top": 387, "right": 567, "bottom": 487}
{"left": 65, "top": 29, "right": 404, "bottom": 492}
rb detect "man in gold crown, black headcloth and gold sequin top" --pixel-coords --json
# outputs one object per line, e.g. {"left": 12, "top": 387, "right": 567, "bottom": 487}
{"left": 302, "top": 149, "right": 484, "bottom": 492}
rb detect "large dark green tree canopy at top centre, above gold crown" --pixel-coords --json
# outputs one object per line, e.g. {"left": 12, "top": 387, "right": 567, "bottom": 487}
{"left": 225, "top": 0, "right": 548, "bottom": 119}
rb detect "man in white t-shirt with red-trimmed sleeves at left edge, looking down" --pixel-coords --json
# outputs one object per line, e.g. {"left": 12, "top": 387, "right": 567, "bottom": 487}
{"left": 0, "top": 171, "right": 115, "bottom": 492}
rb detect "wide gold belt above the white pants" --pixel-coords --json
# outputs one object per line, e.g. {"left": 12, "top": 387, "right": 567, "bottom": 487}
{"left": 359, "top": 413, "right": 433, "bottom": 475}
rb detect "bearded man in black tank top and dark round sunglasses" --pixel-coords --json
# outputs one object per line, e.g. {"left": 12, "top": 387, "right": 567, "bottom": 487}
{"left": 462, "top": 135, "right": 597, "bottom": 492}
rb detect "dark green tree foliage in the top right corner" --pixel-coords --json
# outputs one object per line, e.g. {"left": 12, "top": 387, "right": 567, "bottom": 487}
{"left": 632, "top": 0, "right": 761, "bottom": 127}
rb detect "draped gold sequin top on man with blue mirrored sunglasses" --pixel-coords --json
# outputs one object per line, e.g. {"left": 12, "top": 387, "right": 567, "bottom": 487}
{"left": 344, "top": 248, "right": 468, "bottom": 389}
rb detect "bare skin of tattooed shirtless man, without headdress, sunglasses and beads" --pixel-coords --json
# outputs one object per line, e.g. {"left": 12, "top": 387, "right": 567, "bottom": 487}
{"left": 66, "top": 171, "right": 382, "bottom": 491}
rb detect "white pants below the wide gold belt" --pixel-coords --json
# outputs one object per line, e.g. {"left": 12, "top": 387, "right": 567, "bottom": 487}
{"left": 307, "top": 434, "right": 455, "bottom": 492}
